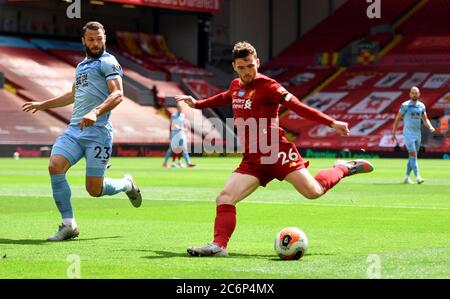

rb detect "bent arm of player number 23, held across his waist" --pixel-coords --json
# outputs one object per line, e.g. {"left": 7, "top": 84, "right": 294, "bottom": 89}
{"left": 80, "top": 77, "right": 123, "bottom": 130}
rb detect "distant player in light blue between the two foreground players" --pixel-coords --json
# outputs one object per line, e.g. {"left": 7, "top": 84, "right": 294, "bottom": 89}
{"left": 163, "top": 104, "right": 195, "bottom": 167}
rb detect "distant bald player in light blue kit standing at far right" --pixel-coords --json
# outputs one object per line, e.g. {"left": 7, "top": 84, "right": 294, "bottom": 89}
{"left": 392, "top": 86, "right": 434, "bottom": 184}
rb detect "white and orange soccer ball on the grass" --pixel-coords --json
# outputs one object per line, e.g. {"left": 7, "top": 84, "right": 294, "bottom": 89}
{"left": 275, "top": 227, "right": 308, "bottom": 260}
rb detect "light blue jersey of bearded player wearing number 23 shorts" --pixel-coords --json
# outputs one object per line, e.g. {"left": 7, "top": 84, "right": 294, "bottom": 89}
{"left": 70, "top": 52, "right": 123, "bottom": 131}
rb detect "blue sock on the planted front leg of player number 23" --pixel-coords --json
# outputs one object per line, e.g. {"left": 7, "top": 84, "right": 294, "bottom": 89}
{"left": 50, "top": 174, "right": 73, "bottom": 219}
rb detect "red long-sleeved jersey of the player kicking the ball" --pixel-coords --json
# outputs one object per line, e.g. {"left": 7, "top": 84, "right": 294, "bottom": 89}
{"left": 195, "top": 74, "right": 334, "bottom": 157}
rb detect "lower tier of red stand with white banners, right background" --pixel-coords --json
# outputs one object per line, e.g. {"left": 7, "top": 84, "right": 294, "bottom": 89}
{"left": 280, "top": 66, "right": 450, "bottom": 151}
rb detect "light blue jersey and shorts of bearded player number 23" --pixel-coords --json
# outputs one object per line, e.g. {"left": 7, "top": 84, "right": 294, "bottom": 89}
{"left": 51, "top": 52, "right": 123, "bottom": 177}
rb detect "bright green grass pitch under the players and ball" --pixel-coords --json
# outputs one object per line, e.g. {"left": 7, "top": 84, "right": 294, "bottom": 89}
{"left": 0, "top": 158, "right": 450, "bottom": 278}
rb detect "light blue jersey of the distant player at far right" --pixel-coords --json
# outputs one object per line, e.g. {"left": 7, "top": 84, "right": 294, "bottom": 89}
{"left": 400, "top": 100, "right": 425, "bottom": 138}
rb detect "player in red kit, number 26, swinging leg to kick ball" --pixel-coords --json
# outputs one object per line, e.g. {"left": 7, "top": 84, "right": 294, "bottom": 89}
{"left": 176, "top": 42, "right": 373, "bottom": 256}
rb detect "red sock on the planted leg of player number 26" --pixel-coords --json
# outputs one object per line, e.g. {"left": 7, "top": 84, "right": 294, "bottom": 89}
{"left": 213, "top": 205, "right": 236, "bottom": 248}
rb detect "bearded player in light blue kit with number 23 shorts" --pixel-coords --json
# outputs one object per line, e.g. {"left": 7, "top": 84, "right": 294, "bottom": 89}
{"left": 22, "top": 22, "right": 142, "bottom": 241}
